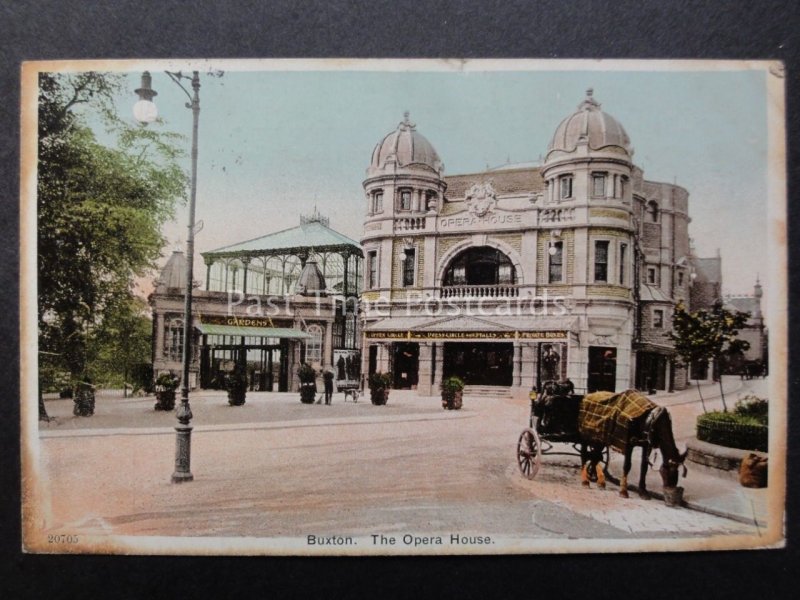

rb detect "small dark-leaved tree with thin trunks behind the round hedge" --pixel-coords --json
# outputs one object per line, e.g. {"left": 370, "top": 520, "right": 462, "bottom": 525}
{"left": 667, "top": 301, "right": 750, "bottom": 412}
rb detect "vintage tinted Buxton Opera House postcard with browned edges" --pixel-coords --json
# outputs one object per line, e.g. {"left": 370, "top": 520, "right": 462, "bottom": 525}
{"left": 20, "top": 59, "right": 787, "bottom": 556}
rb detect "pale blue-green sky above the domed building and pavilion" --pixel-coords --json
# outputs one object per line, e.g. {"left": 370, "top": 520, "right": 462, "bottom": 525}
{"left": 97, "top": 63, "right": 769, "bottom": 293}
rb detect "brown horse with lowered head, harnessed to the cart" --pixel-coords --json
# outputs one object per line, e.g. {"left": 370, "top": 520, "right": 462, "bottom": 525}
{"left": 581, "top": 390, "right": 688, "bottom": 499}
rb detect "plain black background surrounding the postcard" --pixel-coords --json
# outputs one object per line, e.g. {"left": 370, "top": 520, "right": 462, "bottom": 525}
{"left": 0, "top": 0, "right": 800, "bottom": 600}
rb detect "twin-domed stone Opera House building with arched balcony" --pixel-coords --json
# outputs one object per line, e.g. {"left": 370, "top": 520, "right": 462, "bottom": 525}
{"left": 361, "top": 90, "right": 716, "bottom": 395}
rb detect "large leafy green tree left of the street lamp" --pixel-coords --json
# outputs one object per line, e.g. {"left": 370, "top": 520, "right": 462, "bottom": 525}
{"left": 37, "top": 72, "right": 187, "bottom": 412}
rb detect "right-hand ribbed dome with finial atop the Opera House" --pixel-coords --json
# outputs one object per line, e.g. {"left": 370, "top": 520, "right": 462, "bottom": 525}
{"left": 547, "top": 88, "right": 632, "bottom": 154}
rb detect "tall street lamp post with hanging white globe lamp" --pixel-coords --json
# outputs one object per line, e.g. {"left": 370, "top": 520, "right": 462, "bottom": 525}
{"left": 133, "top": 71, "right": 200, "bottom": 483}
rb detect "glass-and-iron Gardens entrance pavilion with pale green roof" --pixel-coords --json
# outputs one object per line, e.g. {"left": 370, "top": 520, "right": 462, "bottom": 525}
{"left": 149, "top": 210, "right": 363, "bottom": 391}
